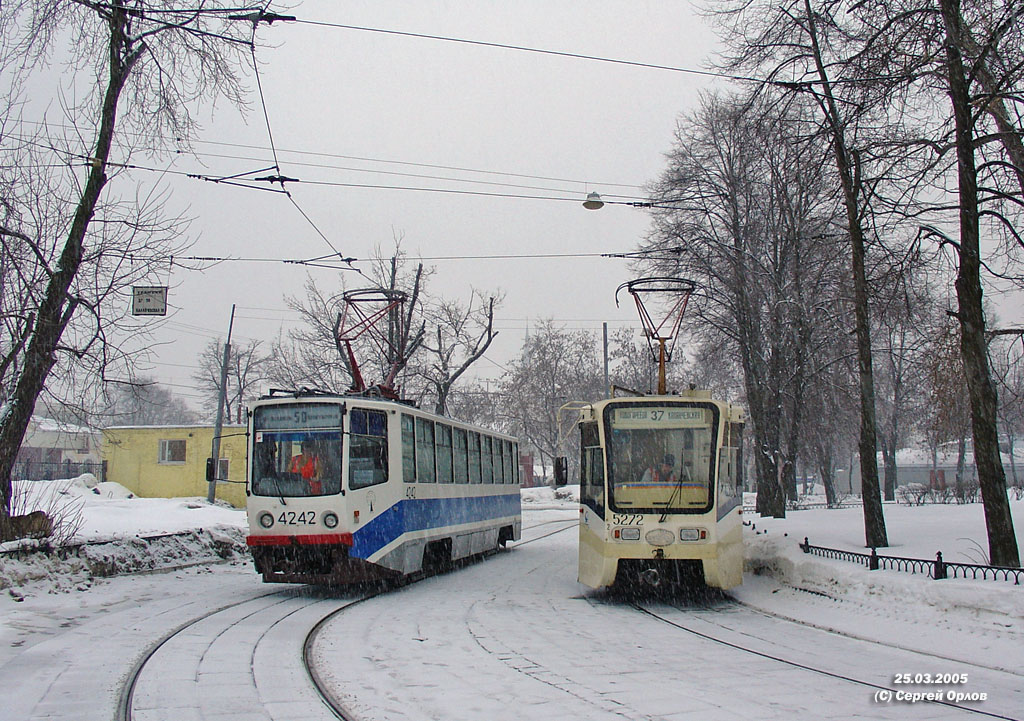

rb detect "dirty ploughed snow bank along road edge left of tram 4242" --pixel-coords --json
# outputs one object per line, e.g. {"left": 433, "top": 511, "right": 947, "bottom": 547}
{"left": 0, "top": 525, "right": 248, "bottom": 598}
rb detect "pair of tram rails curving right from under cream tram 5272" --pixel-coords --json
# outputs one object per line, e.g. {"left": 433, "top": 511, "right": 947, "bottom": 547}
{"left": 629, "top": 597, "right": 1024, "bottom": 721}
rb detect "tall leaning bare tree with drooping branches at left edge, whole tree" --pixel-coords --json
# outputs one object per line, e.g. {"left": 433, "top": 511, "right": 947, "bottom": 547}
{"left": 0, "top": 0, "right": 258, "bottom": 523}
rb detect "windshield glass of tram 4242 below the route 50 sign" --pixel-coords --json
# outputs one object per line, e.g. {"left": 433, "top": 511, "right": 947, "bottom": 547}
{"left": 252, "top": 431, "right": 341, "bottom": 497}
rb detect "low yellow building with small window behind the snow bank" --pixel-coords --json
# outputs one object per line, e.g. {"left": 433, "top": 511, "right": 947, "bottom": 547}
{"left": 102, "top": 425, "right": 246, "bottom": 508}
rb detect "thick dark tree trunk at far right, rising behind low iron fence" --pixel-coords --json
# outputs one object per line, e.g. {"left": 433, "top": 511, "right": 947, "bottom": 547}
{"left": 939, "top": 0, "right": 1020, "bottom": 566}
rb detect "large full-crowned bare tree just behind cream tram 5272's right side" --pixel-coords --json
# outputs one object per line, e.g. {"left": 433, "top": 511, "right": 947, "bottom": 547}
{"left": 644, "top": 90, "right": 845, "bottom": 516}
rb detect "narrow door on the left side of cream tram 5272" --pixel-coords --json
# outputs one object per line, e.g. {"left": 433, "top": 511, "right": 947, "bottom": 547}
{"left": 580, "top": 422, "right": 607, "bottom": 586}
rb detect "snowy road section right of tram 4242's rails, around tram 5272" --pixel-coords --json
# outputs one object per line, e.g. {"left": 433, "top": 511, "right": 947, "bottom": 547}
{"left": 315, "top": 515, "right": 1024, "bottom": 721}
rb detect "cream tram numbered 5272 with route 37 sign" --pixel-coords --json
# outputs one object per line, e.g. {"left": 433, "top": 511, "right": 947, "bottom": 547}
{"left": 579, "top": 390, "right": 743, "bottom": 589}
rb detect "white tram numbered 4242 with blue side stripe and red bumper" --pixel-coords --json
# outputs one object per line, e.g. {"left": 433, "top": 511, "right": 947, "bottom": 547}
{"left": 246, "top": 391, "right": 522, "bottom": 585}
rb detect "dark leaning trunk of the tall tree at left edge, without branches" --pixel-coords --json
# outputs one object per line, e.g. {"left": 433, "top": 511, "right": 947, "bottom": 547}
{"left": 0, "top": 8, "right": 140, "bottom": 525}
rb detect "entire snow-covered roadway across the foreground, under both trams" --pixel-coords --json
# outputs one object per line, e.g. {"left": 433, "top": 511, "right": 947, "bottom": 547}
{"left": 0, "top": 504, "right": 1024, "bottom": 721}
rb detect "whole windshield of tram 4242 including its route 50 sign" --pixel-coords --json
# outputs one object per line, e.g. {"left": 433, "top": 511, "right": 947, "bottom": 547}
{"left": 251, "top": 404, "right": 342, "bottom": 498}
